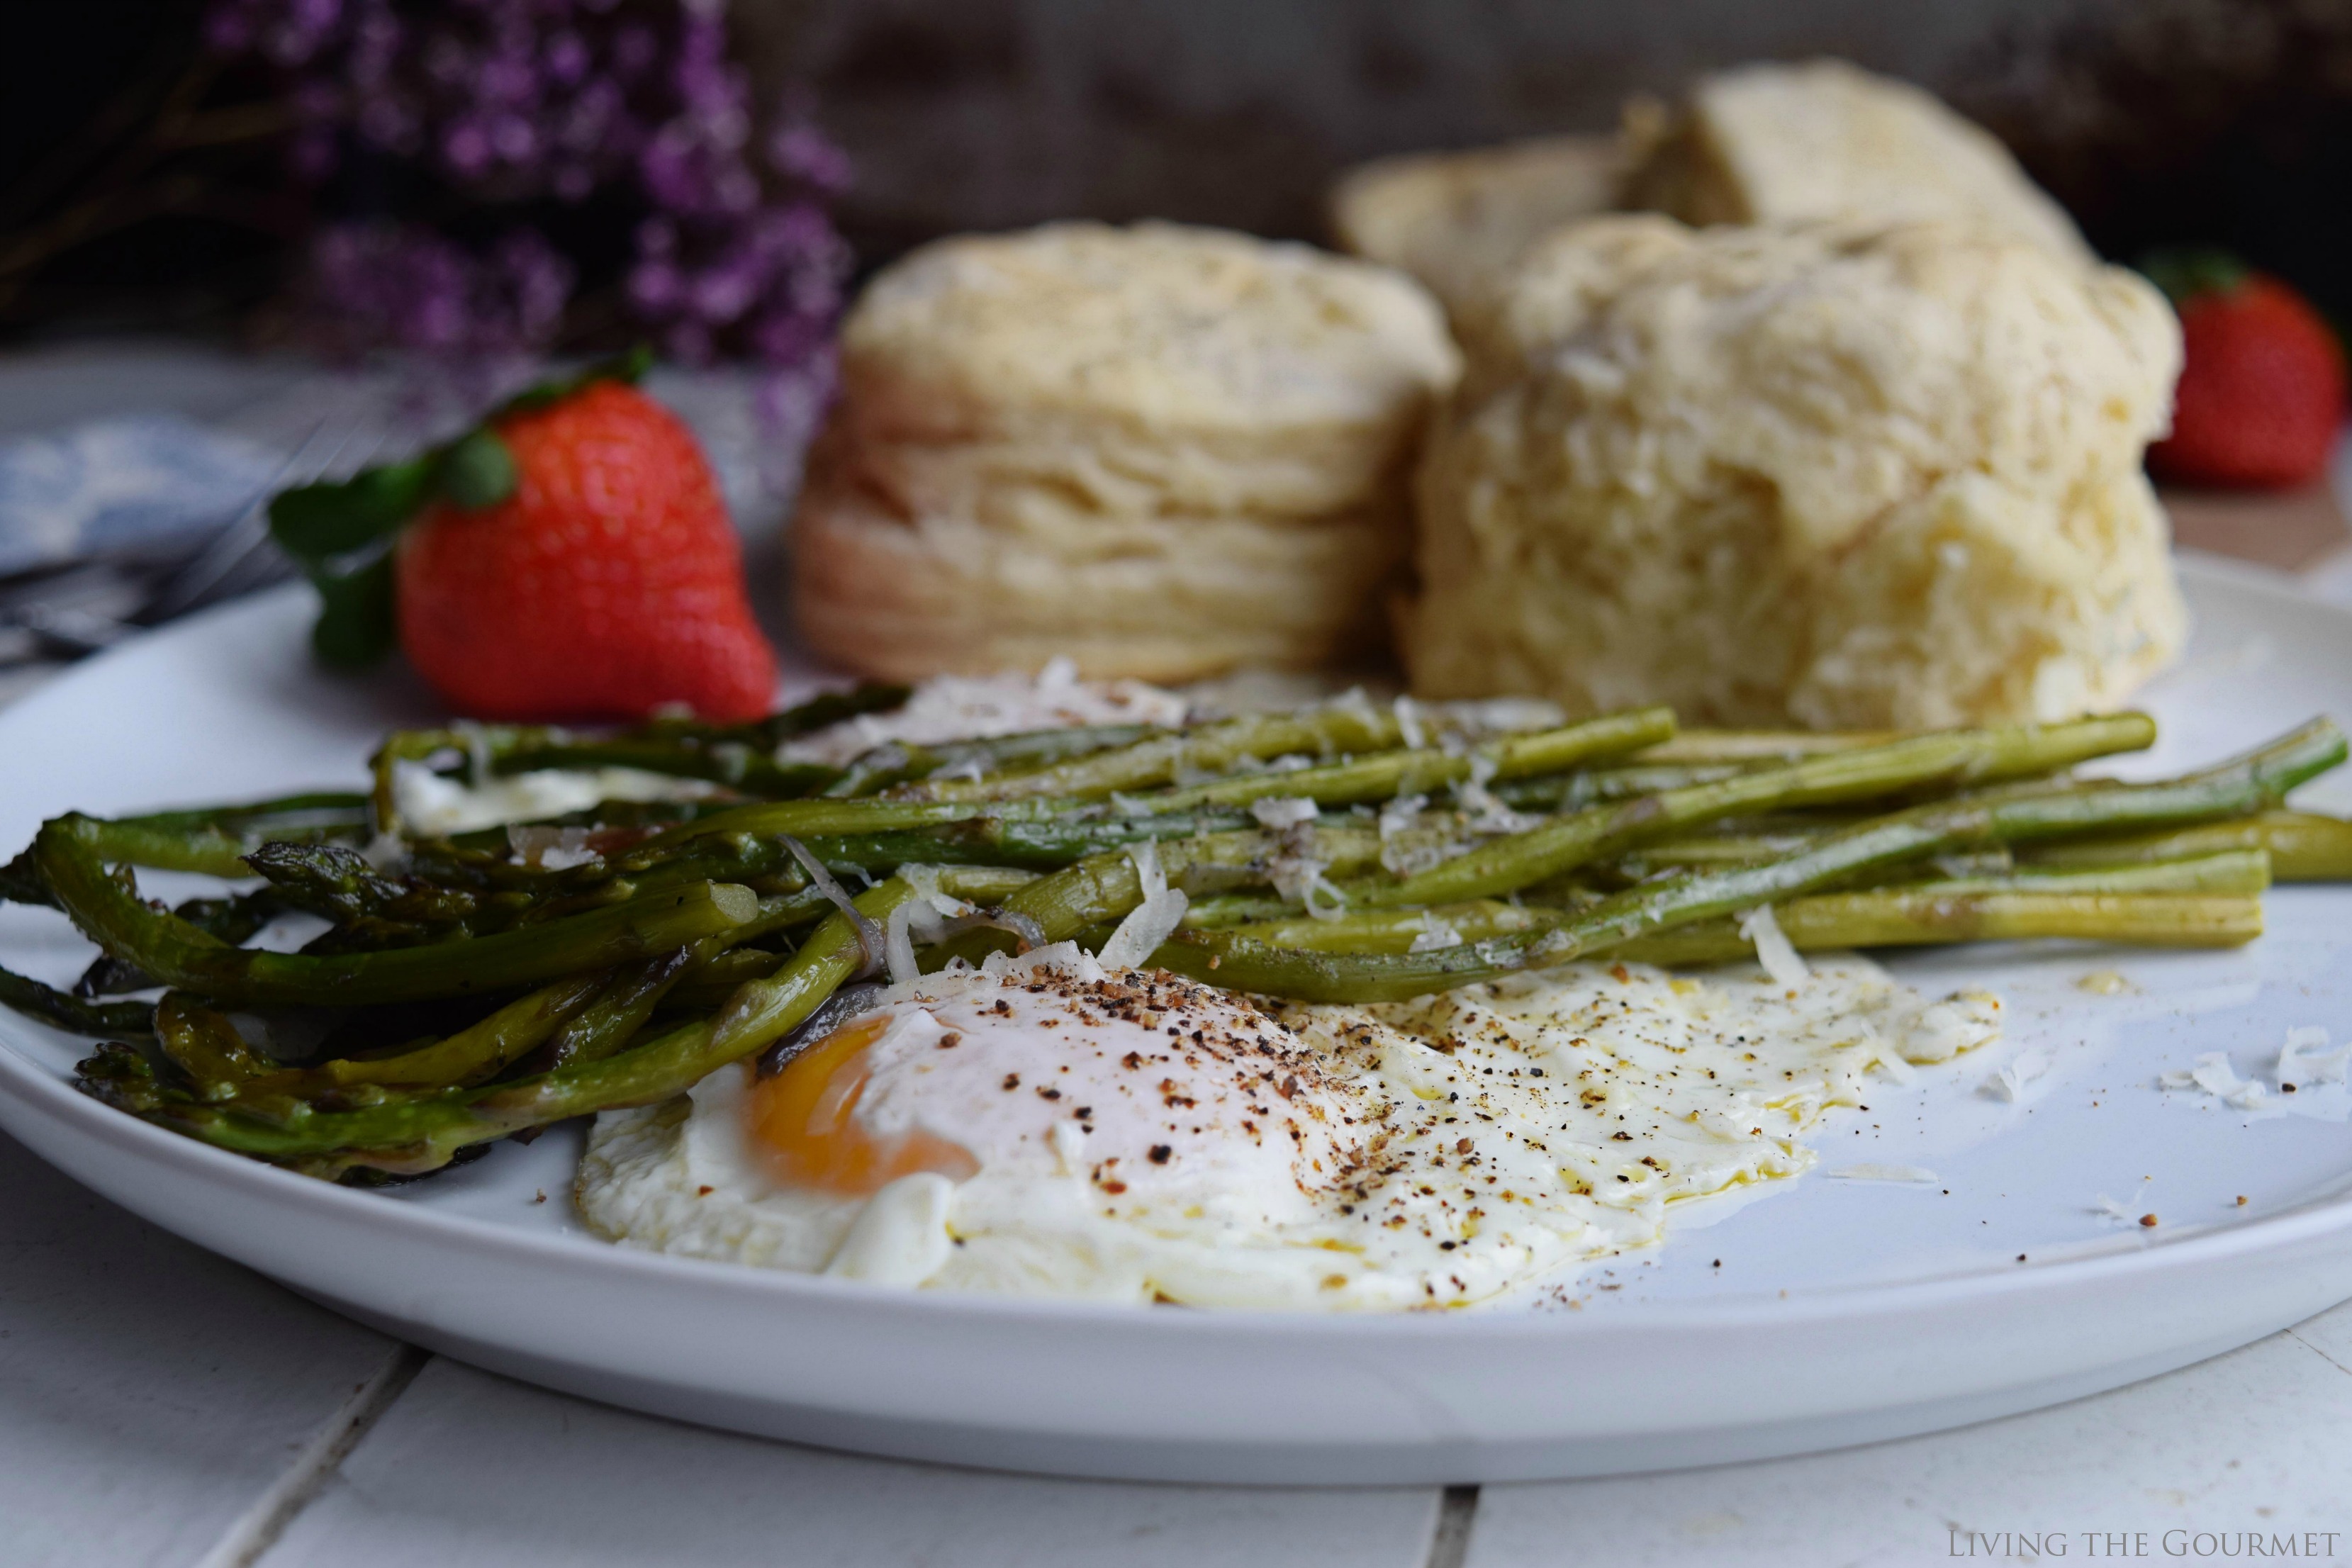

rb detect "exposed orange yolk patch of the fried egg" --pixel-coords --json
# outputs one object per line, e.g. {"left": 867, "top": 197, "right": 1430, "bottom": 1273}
{"left": 746, "top": 1013, "right": 981, "bottom": 1197}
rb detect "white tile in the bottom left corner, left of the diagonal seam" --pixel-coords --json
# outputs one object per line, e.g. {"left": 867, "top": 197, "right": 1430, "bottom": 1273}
{"left": 0, "top": 1138, "right": 393, "bottom": 1568}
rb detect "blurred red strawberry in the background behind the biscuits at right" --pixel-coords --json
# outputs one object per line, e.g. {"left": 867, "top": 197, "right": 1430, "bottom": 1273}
{"left": 2147, "top": 256, "right": 2345, "bottom": 484}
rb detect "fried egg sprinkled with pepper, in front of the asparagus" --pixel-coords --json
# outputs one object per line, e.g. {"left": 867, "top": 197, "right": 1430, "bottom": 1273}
{"left": 576, "top": 945, "right": 1999, "bottom": 1312}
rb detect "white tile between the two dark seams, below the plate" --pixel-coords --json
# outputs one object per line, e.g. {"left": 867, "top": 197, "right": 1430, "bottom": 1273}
{"left": 261, "top": 1350, "right": 1437, "bottom": 1568}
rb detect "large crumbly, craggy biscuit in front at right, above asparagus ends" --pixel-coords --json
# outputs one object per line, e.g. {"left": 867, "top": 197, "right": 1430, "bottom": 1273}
{"left": 1402, "top": 218, "right": 2185, "bottom": 729}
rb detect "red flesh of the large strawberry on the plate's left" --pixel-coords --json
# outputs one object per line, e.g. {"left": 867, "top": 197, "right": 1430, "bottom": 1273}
{"left": 395, "top": 381, "right": 776, "bottom": 722}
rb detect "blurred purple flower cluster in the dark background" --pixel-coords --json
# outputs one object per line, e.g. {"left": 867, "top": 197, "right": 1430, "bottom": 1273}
{"left": 207, "top": 0, "right": 849, "bottom": 392}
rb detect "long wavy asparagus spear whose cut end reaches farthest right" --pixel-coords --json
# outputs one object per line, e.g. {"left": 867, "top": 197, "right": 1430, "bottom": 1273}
{"left": 1133, "top": 719, "right": 2345, "bottom": 1002}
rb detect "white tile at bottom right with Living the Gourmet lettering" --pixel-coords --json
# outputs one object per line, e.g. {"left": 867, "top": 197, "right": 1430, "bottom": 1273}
{"left": 1467, "top": 1305, "right": 2352, "bottom": 1568}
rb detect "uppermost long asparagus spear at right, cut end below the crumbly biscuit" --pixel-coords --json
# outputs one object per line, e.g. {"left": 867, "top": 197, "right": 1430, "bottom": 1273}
{"left": 1350, "top": 712, "right": 2157, "bottom": 905}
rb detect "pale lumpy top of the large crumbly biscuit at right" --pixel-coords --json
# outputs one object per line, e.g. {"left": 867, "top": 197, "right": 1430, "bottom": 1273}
{"left": 1465, "top": 216, "right": 2180, "bottom": 555}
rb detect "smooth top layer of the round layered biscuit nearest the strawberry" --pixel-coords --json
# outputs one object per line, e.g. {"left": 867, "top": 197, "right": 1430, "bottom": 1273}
{"left": 842, "top": 223, "right": 1456, "bottom": 513}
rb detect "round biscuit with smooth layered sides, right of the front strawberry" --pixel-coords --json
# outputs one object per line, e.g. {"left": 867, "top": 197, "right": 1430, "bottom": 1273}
{"left": 793, "top": 223, "right": 1456, "bottom": 679}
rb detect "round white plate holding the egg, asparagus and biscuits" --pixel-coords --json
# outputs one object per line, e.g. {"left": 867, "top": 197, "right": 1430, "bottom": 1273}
{"left": 0, "top": 564, "right": 2352, "bottom": 1484}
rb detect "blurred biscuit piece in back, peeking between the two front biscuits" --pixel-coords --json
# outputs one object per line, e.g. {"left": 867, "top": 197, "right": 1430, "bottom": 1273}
{"left": 1331, "top": 136, "right": 1625, "bottom": 318}
